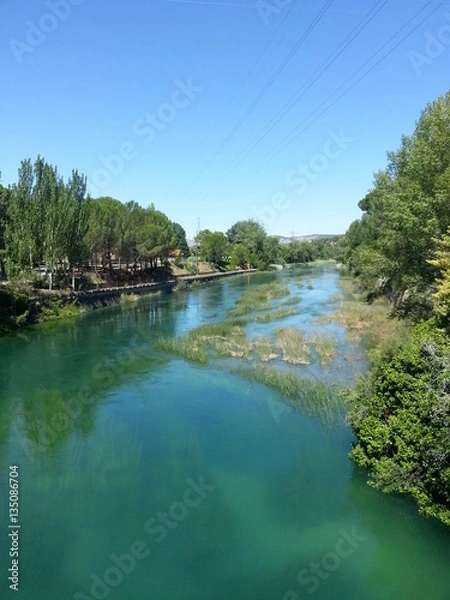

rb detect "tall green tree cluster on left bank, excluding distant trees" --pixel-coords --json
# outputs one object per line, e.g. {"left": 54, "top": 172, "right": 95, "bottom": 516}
{"left": 0, "top": 157, "right": 189, "bottom": 289}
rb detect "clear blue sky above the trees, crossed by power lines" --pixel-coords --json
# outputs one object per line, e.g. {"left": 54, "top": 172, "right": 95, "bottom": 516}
{"left": 0, "top": 0, "right": 450, "bottom": 237}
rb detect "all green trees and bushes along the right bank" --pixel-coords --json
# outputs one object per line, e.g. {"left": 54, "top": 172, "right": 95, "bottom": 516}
{"left": 338, "top": 93, "right": 450, "bottom": 525}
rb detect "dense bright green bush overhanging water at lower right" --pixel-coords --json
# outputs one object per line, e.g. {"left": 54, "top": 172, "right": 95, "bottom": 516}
{"left": 350, "top": 325, "right": 450, "bottom": 525}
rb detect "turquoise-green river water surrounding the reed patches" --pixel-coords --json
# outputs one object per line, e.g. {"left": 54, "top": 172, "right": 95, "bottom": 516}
{"left": 0, "top": 266, "right": 450, "bottom": 600}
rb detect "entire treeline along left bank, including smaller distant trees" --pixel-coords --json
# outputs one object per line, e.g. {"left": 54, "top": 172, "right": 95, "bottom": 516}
{"left": 0, "top": 156, "right": 335, "bottom": 289}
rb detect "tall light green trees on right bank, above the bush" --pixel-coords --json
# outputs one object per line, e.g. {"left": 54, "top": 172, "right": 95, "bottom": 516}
{"left": 340, "top": 92, "right": 450, "bottom": 319}
